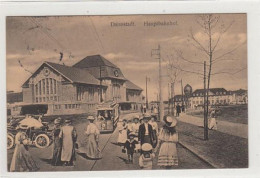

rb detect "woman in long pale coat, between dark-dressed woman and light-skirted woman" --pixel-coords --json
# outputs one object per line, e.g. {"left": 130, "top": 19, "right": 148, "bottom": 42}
{"left": 59, "top": 119, "right": 77, "bottom": 166}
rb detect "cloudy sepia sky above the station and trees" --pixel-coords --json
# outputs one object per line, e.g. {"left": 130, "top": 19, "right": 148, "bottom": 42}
{"left": 6, "top": 14, "right": 247, "bottom": 100}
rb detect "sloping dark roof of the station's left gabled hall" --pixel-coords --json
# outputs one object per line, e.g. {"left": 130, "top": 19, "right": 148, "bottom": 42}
{"left": 45, "top": 62, "right": 100, "bottom": 85}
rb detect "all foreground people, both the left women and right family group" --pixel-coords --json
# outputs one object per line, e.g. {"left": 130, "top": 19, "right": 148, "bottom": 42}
{"left": 10, "top": 113, "right": 178, "bottom": 172}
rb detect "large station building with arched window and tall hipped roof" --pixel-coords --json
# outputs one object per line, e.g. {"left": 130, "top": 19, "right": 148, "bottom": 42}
{"left": 14, "top": 55, "right": 142, "bottom": 114}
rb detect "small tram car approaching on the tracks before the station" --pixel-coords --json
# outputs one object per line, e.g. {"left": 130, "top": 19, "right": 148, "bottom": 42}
{"left": 94, "top": 105, "right": 119, "bottom": 133}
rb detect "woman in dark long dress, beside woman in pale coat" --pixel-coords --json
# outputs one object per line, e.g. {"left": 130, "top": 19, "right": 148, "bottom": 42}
{"left": 51, "top": 117, "right": 62, "bottom": 166}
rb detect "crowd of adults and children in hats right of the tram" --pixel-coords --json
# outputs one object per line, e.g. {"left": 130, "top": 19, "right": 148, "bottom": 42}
{"left": 118, "top": 113, "right": 178, "bottom": 169}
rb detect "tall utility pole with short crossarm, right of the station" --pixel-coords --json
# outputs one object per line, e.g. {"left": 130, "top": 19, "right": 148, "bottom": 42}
{"left": 151, "top": 45, "right": 164, "bottom": 121}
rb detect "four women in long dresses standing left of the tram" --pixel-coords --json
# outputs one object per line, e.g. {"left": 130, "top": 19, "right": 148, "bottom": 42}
{"left": 10, "top": 116, "right": 101, "bottom": 172}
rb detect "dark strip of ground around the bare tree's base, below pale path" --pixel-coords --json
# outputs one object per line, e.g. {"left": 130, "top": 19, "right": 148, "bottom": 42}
{"left": 177, "top": 121, "right": 248, "bottom": 168}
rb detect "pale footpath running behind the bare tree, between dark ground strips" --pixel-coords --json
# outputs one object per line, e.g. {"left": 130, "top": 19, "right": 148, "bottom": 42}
{"left": 178, "top": 113, "right": 248, "bottom": 138}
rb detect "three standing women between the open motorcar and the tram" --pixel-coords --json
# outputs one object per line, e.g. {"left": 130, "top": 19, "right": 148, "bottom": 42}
{"left": 52, "top": 116, "right": 101, "bottom": 166}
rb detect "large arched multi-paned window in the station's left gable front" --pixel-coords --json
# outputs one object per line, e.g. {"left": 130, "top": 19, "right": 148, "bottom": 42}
{"left": 34, "top": 78, "right": 59, "bottom": 103}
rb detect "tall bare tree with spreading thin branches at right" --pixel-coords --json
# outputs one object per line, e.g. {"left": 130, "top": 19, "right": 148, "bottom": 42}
{"left": 176, "top": 14, "right": 243, "bottom": 131}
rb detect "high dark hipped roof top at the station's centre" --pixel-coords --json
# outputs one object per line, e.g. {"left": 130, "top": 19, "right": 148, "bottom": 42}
{"left": 73, "top": 55, "right": 118, "bottom": 68}
